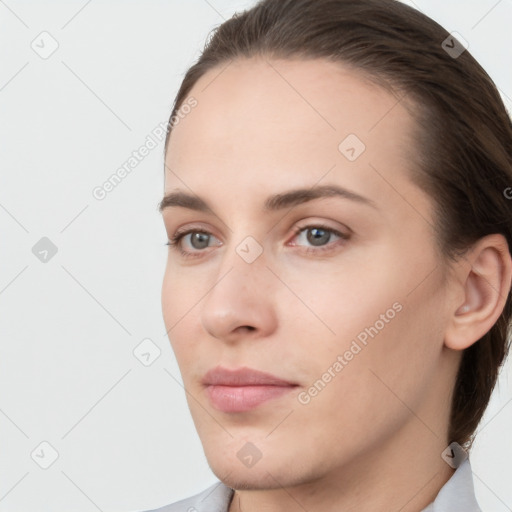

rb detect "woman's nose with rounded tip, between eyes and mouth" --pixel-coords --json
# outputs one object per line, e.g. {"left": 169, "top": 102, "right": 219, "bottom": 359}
{"left": 201, "top": 244, "right": 277, "bottom": 343}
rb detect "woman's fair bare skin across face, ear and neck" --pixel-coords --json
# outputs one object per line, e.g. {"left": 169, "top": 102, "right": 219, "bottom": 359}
{"left": 162, "top": 58, "right": 512, "bottom": 512}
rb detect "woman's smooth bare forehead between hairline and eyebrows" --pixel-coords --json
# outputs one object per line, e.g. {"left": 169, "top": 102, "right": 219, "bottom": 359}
{"left": 166, "top": 58, "right": 426, "bottom": 219}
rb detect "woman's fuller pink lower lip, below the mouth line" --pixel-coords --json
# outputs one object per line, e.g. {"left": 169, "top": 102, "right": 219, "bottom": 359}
{"left": 206, "top": 386, "right": 296, "bottom": 412}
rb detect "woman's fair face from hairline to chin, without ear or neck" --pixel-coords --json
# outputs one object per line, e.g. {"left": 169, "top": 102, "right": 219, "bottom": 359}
{"left": 162, "top": 59, "right": 454, "bottom": 489}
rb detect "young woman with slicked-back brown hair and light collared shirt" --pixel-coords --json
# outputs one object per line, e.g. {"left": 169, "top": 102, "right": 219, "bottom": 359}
{"left": 152, "top": 0, "right": 512, "bottom": 512}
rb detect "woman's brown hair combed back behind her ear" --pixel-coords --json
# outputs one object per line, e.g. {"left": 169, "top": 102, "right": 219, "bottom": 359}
{"left": 165, "top": 0, "right": 512, "bottom": 449}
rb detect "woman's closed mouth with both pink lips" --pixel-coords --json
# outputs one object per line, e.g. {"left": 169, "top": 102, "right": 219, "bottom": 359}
{"left": 202, "top": 367, "right": 298, "bottom": 413}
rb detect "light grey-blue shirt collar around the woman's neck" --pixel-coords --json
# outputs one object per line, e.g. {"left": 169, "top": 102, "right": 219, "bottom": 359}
{"left": 146, "top": 458, "right": 482, "bottom": 512}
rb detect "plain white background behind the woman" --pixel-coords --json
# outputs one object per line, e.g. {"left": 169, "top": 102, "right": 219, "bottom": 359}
{"left": 0, "top": 0, "right": 512, "bottom": 512}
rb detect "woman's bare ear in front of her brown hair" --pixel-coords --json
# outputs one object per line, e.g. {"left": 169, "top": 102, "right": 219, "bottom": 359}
{"left": 445, "top": 234, "right": 512, "bottom": 350}
